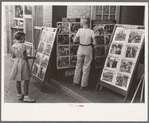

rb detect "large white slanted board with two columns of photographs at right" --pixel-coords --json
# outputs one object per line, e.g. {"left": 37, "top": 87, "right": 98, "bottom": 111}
{"left": 101, "top": 25, "right": 144, "bottom": 91}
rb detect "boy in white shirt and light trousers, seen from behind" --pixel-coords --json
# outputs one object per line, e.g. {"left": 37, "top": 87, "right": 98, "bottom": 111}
{"left": 73, "top": 16, "right": 96, "bottom": 89}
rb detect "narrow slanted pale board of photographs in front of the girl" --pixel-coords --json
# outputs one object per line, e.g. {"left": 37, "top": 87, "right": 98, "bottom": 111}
{"left": 32, "top": 28, "right": 56, "bottom": 81}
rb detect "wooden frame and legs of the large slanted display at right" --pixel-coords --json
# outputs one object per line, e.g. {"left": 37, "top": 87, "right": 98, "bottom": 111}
{"left": 95, "top": 24, "right": 144, "bottom": 102}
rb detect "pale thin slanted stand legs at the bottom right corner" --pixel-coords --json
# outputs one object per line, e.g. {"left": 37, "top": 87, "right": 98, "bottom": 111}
{"left": 131, "top": 74, "right": 145, "bottom": 103}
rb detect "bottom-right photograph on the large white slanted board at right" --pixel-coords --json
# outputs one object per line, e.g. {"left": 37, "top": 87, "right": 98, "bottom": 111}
{"left": 115, "top": 73, "right": 129, "bottom": 88}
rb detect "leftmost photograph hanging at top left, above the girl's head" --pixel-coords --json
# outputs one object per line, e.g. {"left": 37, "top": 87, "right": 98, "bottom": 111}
{"left": 15, "top": 5, "right": 23, "bottom": 18}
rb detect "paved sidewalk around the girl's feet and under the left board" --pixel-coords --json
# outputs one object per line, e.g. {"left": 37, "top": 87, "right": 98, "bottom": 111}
{"left": 4, "top": 54, "right": 79, "bottom": 103}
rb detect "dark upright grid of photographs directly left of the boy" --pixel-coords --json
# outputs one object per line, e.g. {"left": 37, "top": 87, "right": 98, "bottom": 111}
{"left": 57, "top": 22, "right": 81, "bottom": 69}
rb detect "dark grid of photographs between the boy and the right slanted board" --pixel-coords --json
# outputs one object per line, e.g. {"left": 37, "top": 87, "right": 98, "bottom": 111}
{"left": 93, "top": 24, "right": 114, "bottom": 68}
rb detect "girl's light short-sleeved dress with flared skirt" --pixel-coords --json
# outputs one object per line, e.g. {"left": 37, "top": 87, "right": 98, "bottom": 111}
{"left": 10, "top": 43, "right": 31, "bottom": 81}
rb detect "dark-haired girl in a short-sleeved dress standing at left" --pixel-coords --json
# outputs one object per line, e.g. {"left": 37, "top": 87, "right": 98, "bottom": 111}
{"left": 10, "top": 32, "right": 35, "bottom": 102}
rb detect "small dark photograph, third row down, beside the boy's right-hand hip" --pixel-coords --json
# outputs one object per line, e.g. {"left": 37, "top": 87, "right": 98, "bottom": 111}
{"left": 94, "top": 46, "right": 105, "bottom": 56}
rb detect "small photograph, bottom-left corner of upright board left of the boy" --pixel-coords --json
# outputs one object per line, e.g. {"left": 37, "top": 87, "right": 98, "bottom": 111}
{"left": 57, "top": 57, "right": 69, "bottom": 69}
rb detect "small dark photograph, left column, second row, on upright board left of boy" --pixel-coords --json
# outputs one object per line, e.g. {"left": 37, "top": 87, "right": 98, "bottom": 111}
{"left": 58, "top": 35, "right": 69, "bottom": 45}
